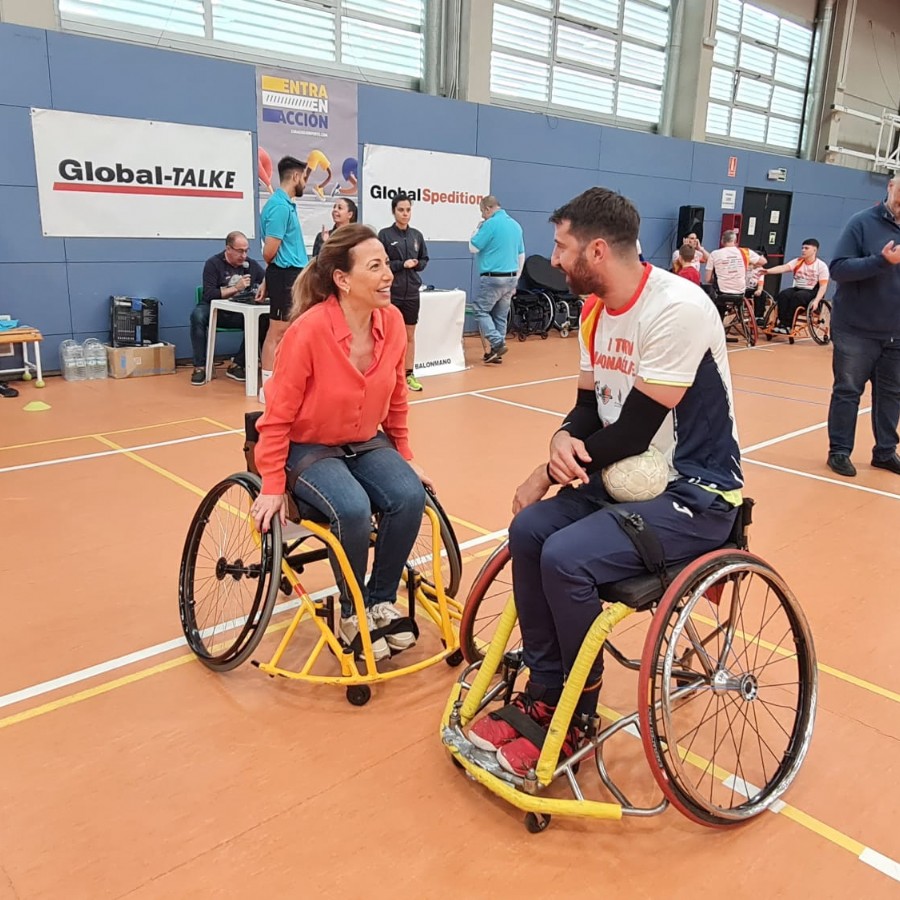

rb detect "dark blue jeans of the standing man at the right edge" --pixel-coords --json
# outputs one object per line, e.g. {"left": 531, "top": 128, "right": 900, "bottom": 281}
{"left": 828, "top": 330, "right": 900, "bottom": 460}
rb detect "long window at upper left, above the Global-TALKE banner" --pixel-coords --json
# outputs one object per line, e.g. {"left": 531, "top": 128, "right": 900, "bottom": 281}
{"left": 56, "top": 0, "right": 427, "bottom": 89}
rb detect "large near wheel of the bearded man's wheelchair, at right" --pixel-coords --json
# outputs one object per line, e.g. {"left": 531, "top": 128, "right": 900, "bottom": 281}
{"left": 638, "top": 550, "right": 817, "bottom": 826}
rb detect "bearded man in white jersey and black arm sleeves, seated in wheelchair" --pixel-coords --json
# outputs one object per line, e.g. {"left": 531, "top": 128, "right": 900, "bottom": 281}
{"left": 469, "top": 188, "right": 743, "bottom": 775}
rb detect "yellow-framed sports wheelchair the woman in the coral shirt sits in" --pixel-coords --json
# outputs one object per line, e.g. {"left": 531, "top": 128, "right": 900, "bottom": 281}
{"left": 178, "top": 413, "right": 463, "bottom": 706}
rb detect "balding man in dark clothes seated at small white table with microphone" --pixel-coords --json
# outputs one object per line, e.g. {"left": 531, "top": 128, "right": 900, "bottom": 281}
{"left": 191, "top": 231, "right": 266, "bottom": 385}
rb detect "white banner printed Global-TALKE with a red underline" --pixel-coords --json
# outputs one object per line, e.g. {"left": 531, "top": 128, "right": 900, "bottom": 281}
{"left": 31, "top": 109, "right": 256, "bottom": 239}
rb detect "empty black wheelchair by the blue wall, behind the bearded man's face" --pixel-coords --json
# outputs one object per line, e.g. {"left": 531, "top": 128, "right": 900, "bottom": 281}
{"left": 510, "top": 254, "right": 582, "bottom": 341}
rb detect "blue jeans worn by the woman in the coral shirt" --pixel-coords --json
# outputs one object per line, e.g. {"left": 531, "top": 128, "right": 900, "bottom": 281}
{"left": 288, "top": 444, "right": 425, "bottom": 618}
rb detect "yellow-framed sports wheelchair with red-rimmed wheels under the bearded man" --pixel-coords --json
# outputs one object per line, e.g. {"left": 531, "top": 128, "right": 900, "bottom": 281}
{"left": 441, "top": 500, "right": 817, "bottom": 832}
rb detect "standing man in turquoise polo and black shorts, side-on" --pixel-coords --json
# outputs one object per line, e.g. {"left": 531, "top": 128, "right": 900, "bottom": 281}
{"left": 259, "top": 156, "right": 309, "bottom": 403}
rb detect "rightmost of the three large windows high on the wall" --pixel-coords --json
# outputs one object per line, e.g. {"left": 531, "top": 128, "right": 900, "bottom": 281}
{"left": 704, "top": 0, "right": 817, "bottom": 156}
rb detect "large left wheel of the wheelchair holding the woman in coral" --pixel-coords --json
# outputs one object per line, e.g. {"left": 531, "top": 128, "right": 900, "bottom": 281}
{"left": 178, "top": 472, "right": 282, "bottom": 672}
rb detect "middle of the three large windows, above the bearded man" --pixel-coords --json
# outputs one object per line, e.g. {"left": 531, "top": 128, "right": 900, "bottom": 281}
{"left": 490, "top": 0, "right": 674, "bottom": 131}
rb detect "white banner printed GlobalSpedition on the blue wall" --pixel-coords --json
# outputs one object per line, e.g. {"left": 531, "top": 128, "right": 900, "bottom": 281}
{"left": 360, "top": 144, "right": 491, "bottom": 242}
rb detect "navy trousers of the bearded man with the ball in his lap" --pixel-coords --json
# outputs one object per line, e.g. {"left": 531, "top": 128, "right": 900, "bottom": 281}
{"left": 509, "top": 479, "right": 737, "bottom": 689}
